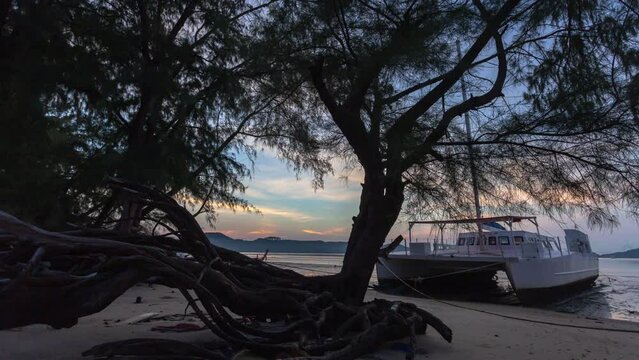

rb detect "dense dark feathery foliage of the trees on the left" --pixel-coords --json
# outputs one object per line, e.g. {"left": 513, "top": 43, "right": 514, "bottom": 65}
{"left": 0, "top": 0, "right": 326, "bottom": 227}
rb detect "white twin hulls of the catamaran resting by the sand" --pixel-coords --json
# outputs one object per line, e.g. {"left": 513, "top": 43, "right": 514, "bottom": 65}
{"left": 377, "top": 253, "right": 599, "bottom": 305}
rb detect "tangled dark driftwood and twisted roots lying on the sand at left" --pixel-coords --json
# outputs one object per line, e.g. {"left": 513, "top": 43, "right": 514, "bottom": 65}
{"left": 0, "top": 180, "right": 452, "bottom": 359}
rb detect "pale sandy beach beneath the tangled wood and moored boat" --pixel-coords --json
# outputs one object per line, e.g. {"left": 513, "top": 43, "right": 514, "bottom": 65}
{"left": 0, "top": 285, "right": 639, "bottom": 360}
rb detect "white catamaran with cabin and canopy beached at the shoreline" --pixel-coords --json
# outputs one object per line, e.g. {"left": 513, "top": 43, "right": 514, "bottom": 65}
{"left": 377, "top": 216, "right": 599, "bottom": 304}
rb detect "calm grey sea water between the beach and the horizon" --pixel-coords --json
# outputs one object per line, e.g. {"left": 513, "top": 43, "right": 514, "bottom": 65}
{"left": 247, "top": 253, "right": 639, "bottom": 322}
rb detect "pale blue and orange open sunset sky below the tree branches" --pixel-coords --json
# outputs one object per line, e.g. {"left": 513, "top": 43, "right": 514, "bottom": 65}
{"left": 200, "top": 151, "right": 639, "bottom": 254}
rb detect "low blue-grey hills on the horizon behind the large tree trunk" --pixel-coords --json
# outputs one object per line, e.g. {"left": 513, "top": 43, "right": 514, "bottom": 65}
{"left": 206, "top": 232, "right": 404, "bottom": 254}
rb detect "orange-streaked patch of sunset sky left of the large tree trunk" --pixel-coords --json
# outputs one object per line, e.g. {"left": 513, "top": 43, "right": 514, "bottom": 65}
{"left": 202, "top": 151, "right": 362, "bottom": 241}
